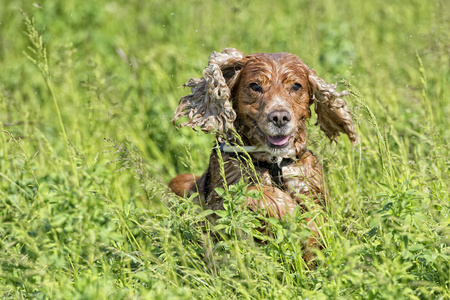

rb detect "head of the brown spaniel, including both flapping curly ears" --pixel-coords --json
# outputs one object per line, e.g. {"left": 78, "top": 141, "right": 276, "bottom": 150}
{"left": 174, "top": 48, "right": 359, "bottom": 157}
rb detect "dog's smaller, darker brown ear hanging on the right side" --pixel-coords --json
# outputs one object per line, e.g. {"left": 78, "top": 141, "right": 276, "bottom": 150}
{"left": 308, "top": 69, "right": 359, "bottom": 145}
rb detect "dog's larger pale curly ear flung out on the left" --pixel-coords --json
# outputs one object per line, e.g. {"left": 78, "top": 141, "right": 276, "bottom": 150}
{"left": 172, "top": 48, "right": 245, "bottom": 134}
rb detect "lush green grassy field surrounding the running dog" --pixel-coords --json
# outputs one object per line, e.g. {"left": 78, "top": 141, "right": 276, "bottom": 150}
{"left": 0, "top": 0, "right": 450, "bottom": 299}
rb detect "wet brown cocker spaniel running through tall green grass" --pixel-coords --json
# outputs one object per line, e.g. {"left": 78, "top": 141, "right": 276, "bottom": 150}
{"left": 169, "top": 48, "right": 359, "bottom": 241}
